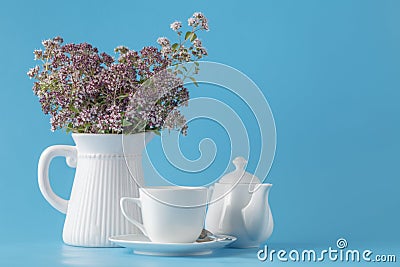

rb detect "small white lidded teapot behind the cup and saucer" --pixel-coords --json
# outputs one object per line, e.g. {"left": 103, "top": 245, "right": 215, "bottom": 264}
{"left": 205, "top": 157, "right": 274, "bottom": 248}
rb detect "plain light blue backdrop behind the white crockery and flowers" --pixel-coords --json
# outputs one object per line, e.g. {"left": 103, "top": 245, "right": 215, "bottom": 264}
{"left": 0, "top": 0, "right": 400, "bottom": 266}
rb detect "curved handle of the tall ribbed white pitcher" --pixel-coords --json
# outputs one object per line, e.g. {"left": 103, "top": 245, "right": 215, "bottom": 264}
{"left": 38, "top": 145, "right": 77, "bottom": 214}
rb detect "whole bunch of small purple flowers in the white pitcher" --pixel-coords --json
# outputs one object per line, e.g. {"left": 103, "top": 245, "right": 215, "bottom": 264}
{"left": 27, "top": 13, "right": 208, "bottom": 134}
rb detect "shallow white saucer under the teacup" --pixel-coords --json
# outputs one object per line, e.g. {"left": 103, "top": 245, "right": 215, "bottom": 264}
{"left": 109, "top": 234, "right": 236, "bottom": 256}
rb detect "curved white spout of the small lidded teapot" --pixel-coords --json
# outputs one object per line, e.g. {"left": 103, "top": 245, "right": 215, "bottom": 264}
{"left": 242, "top": 184, "right": 272, "bottom": 241}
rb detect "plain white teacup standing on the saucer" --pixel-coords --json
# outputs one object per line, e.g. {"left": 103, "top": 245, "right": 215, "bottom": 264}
{"left": 120, "top": 186, "right": 207, "bottom": 243}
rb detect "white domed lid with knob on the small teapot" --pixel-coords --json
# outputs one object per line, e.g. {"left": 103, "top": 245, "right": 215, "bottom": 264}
{"left": 218, "top": 157, "right": 261, "bottom": 184}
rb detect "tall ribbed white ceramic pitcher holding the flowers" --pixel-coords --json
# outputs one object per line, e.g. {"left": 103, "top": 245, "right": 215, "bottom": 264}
{"left": 38, "top": 133, "right": 152, "bottom": 247}
